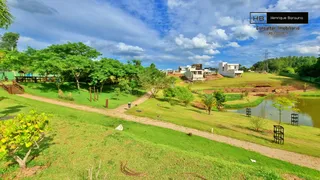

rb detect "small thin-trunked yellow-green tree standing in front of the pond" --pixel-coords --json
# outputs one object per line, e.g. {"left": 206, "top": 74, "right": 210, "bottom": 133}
{"left": 272, "top": 96, "right": 296, "bottom": 124}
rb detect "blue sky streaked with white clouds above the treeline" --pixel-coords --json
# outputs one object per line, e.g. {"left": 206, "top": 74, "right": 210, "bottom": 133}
{"left": 0, "top": 0, "right": 320, "bottom": 69}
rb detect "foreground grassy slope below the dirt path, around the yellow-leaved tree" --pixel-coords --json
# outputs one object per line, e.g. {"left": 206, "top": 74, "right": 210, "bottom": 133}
{"left": 0, "top": 90, "right": 320, "bottom": 179}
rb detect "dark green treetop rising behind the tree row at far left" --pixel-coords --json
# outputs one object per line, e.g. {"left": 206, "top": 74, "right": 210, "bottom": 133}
{"left": 0, "top": 32, "right": 20, "bottom": 51}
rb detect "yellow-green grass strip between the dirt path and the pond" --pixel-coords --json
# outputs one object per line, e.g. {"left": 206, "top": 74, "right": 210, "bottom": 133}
{"left": 128, "top": 99, "right": 320, "bottom": 157}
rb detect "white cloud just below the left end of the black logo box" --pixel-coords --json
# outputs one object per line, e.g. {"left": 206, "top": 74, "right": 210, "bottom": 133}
{"left": 231, "top": 24, "right": 258, "bottom": 40}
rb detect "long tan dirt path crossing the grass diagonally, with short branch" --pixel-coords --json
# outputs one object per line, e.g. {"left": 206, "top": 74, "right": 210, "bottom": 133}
{"left": 18, "top": 94, "right": 320, "bottom": 171}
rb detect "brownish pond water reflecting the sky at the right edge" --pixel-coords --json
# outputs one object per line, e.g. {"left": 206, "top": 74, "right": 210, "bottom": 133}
{"left": 230, "top": 99, "right": 320, "bottom": 128}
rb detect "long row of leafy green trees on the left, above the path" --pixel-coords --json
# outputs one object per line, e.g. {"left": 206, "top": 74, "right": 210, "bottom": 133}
{"left": 0, "top": 33, "right": 172, "bottom": 96}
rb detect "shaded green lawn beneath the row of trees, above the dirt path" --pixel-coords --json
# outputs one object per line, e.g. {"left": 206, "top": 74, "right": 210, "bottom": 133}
{"left": 21, "top": 83, "right": 144, "bottom": 109}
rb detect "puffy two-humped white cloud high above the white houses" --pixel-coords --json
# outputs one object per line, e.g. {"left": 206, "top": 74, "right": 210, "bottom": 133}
{"left": 175, "top": 33, "right": 209, "bottom": 49}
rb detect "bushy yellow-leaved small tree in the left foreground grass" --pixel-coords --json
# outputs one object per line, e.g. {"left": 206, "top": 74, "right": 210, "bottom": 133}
{"left": 0, "top": 111, "right": 48, "bottom": 168}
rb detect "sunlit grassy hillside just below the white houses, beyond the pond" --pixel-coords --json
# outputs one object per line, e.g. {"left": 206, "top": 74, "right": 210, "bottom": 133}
{"left": 186, "top": 72, "right": 314, "bottom": 90}
